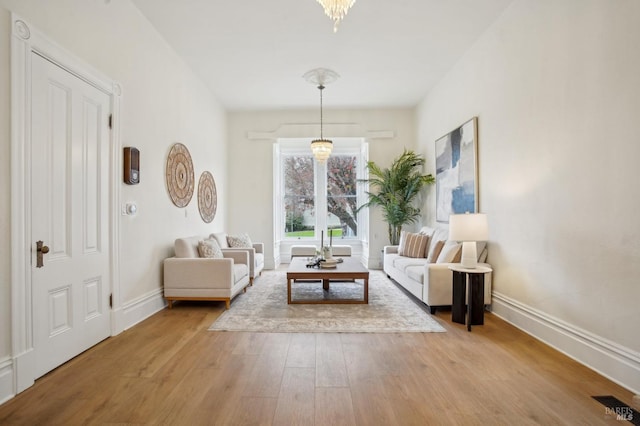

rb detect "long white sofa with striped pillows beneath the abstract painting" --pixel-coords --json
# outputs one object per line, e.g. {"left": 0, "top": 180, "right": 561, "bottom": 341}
{"left": 383, "top": 227, "right": 491, "bottom": 314}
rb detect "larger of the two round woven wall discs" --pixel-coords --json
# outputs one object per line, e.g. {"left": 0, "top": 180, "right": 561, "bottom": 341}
{"left": 167, "top": 143, "right": 195, "bottom": 207}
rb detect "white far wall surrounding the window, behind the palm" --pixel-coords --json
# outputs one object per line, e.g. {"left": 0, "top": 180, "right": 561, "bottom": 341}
{"left": 227, "top": 108, "right": 418, "bottom": 268}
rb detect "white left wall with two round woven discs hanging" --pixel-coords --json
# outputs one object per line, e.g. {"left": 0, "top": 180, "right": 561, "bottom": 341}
{"left": 0, "top": 0, "right": 227, "bottom": 388}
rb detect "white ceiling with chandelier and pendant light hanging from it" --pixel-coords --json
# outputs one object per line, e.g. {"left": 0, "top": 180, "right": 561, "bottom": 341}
{"left": 133, "top": 0, "right": 512, "bottom": 111}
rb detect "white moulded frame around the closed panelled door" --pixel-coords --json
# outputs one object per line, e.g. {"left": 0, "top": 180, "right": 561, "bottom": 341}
{"left": 11, "top": 13, "right": 122, "bottom": 394}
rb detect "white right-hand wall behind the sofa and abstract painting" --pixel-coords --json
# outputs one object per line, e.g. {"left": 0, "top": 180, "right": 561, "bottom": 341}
{"left": 418, "top": 0, "right": 640, "bottom": 392}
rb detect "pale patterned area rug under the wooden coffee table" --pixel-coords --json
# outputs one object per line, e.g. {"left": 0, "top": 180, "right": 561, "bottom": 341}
{"left": 209, "top": 270, "right": 446, "bottom": 333}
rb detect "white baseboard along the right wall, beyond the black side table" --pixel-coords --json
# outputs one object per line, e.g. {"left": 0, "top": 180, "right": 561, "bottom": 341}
{"left": 491, "top": 291, "right": 640, "bottom": 394}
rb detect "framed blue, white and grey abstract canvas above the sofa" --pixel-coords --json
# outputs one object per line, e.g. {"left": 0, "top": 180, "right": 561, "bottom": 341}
{"left": 436, "top": 117, "right": 478, "bottom": 223}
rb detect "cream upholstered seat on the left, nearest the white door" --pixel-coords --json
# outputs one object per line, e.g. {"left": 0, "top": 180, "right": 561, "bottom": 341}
{"left": 164, "top": 236, "right": 249, "bottom": 309}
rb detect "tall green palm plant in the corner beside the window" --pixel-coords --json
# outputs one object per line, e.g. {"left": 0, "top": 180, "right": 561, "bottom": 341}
{"left": 358, "top": 149, "right": 435, "bottom": 245}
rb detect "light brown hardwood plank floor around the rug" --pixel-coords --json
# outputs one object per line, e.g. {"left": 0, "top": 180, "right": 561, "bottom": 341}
{"left": 0, "top": 294, "right": 638, "bottom": 425}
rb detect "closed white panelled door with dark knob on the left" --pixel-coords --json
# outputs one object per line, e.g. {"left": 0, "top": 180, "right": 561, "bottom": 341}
{"left": 30, "top": 53, "right": 111, "bottom": 377}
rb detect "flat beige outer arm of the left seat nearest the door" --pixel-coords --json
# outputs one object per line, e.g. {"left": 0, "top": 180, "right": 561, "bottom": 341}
{"left": 164, "top": 257, "right": 234, "bottom": 288}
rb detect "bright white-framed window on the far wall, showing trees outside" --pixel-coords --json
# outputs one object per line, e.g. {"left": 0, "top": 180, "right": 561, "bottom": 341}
{"left": 274, "top": 139, "right": 367, "bottom": 241}
